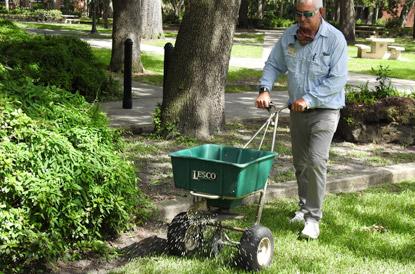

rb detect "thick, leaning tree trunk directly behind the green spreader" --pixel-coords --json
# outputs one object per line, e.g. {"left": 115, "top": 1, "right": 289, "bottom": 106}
{"left": 161, "top": 0, "right": 240, "bottom": 138}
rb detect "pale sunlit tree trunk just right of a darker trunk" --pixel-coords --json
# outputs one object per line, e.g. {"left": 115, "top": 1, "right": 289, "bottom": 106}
{"left": 141, "top": 0, "right": 163, "bottom": 39}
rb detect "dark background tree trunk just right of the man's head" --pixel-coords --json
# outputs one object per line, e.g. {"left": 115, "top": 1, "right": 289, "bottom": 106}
{"left": 340, "top": 0, "right": 356, "bottom": 44}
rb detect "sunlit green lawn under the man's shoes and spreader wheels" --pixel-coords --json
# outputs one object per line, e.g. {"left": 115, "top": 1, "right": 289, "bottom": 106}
{"left": 110, "top": 181, "right": 415, "bottom": 274}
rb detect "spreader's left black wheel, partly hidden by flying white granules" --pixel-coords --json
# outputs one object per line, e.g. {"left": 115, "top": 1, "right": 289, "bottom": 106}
{"left": 167, "top": 212, "right": 203, "bottom": 256}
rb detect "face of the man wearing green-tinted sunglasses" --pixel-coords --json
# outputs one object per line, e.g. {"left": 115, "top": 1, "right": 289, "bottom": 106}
{"left": 296, "top": 1, "right": 321, "bottom": 31}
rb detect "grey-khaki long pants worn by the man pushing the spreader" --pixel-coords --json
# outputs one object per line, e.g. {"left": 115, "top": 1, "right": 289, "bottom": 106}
{"left": 290, "top": 109, "right": 340, "bottom": 221}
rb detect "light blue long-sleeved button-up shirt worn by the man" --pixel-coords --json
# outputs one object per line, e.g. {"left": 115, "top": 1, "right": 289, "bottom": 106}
{"left": 260, "top": 19, "right": 347, "bottom": 109}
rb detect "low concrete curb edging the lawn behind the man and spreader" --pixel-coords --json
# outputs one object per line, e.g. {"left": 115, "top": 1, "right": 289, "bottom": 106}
{"left": 156, "top": 163, "right": 415, "bottom": 222}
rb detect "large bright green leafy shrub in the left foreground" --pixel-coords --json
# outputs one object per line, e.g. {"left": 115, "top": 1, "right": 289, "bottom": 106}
{"left": 0, "top": 64, "right": 153, "bottom": 273}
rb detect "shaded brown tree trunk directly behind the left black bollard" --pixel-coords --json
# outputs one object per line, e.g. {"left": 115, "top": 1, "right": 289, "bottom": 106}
{"left": 110, "top": 0, "right": 143, "bottom": 72}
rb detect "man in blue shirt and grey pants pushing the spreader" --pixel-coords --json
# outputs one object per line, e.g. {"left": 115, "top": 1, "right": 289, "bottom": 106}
{"left": 255, "top": 0, "right": 347, "bottom": 239}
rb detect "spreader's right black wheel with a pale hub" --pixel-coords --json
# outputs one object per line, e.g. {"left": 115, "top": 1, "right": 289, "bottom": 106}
{"left": 238, "top": 225, "right": 274, "bottom": 271}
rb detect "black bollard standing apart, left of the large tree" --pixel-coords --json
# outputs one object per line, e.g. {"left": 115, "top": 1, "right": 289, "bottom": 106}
{"left": 122, "top": 38, "right": 133, "bottom": 109}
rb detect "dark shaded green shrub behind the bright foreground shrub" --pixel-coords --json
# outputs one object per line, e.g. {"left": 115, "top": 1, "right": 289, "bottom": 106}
{"left": 0, "top": 21, "right": 119, "bottom": 101}
